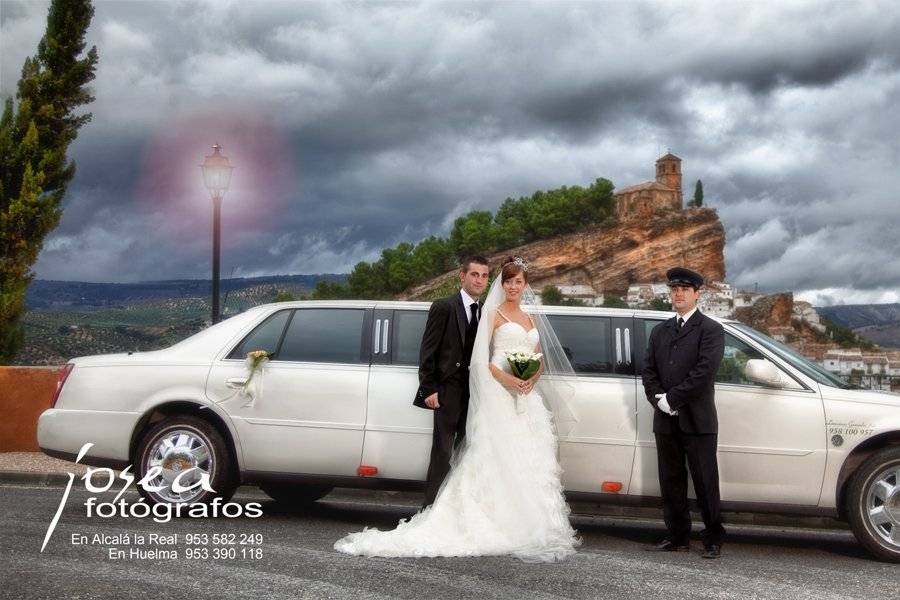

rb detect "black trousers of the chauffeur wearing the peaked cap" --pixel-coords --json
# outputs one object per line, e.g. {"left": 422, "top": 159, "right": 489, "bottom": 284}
{"left": 656, "top": 431, "right": 725, "bottom": 545}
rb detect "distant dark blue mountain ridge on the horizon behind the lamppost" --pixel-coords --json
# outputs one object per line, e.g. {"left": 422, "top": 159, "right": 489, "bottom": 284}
{"left": 25, "top": 273, "right": 347, "bottom": 310}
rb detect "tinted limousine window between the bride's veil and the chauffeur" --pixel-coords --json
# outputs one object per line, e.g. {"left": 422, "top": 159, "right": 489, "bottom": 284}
{"left": 549, "top": 315, "right": 613, "bottom": 374}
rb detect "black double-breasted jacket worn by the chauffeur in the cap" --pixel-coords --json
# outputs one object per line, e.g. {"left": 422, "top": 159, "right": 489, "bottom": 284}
{"left": 641, "top": 310, "right": 725, "bottom": 433}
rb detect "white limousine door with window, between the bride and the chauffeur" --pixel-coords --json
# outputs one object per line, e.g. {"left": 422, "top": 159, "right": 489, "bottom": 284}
{"left": 549, "top": 314, "right": 636, "bottom": 493}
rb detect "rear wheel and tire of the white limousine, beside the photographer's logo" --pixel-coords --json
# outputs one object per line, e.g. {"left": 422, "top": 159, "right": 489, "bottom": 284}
{"left": 135, "top": 415, "right": 237, "bottom": 504}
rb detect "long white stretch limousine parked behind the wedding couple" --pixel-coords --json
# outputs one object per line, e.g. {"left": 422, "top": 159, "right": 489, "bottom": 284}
{"left": 38, "top": 301, "right": 900, "bottom": 562}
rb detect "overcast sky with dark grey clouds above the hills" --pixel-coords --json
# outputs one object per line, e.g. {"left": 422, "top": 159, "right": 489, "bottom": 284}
{"left": 0, "top": 0, "right": 900, "bottom": 305}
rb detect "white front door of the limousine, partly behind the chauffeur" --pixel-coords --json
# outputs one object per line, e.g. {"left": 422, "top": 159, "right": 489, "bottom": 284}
{"left": 634, "top": 319, "right": 826, "bottom": 505}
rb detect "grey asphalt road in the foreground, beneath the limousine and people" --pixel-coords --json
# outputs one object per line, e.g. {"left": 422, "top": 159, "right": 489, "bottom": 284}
{"left": 0, "top": 481, "right": 900, "bottom": 600}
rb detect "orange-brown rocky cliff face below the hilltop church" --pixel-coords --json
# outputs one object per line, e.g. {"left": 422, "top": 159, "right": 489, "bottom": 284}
{"left": 402, "top": 208, "right": 725, "bottom": 300}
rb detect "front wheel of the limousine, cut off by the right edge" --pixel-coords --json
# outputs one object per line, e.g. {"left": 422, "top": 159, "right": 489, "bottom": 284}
{"left": 847, "top": 447, "right": 900, "bottom": 563}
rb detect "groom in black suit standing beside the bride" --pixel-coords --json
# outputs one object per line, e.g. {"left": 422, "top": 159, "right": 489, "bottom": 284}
{"left": 413, "top": 256, "right": 488, "bottom": 507}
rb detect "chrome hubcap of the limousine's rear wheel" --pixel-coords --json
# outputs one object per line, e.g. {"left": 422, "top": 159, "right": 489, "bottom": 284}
{"left": 144, "top": 429, "right": 215, "bottom": 503}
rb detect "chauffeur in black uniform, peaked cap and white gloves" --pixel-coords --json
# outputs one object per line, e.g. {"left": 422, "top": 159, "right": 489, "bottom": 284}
{"left": 641, "top": 267, "right": 725, "bottom": 558}
